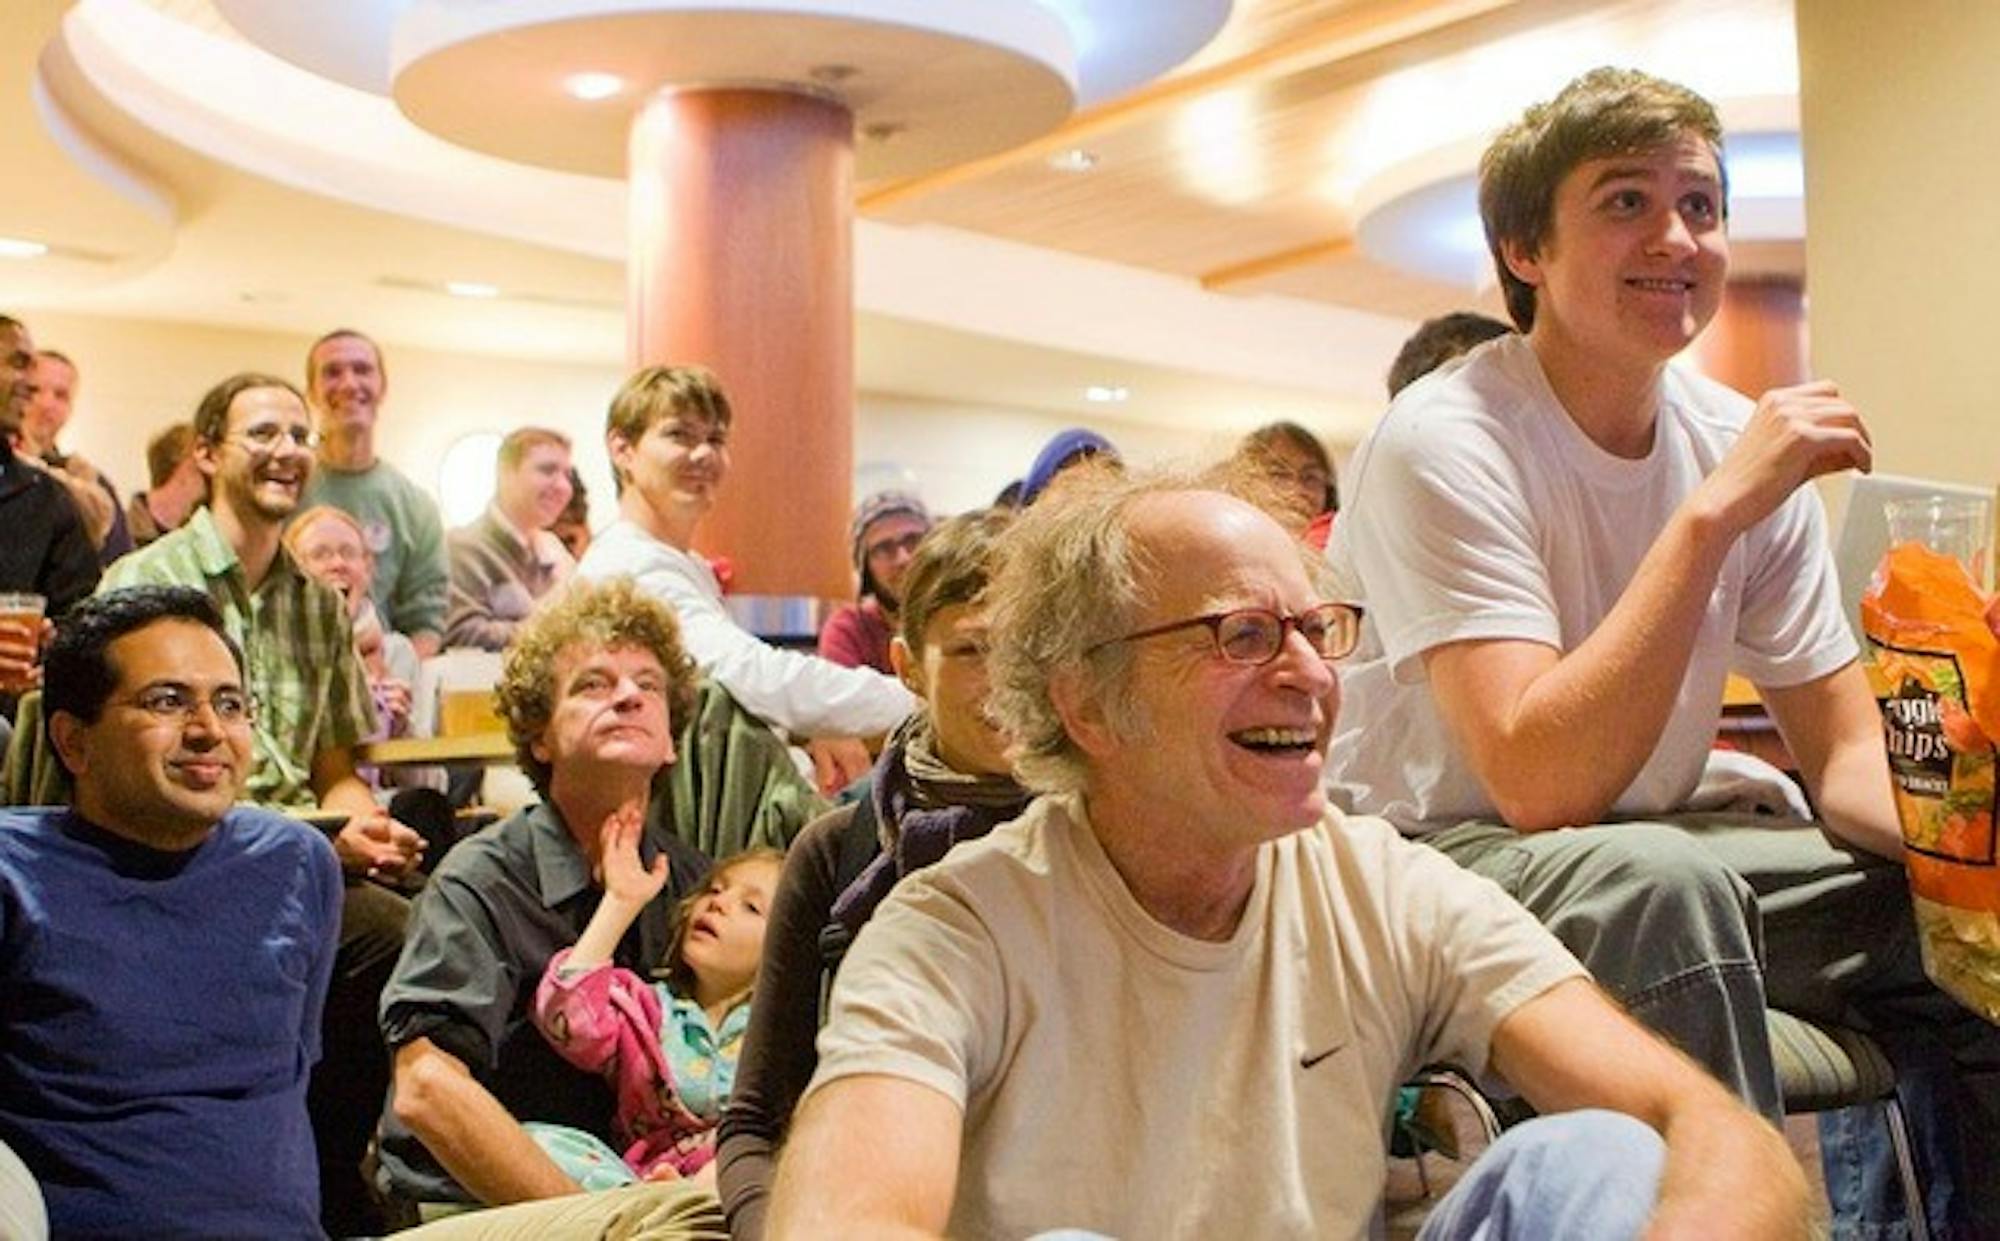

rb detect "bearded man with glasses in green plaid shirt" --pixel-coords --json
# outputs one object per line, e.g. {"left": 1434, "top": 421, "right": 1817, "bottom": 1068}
{"left": 104, "top": 374, "right": 424, "bottom": 1235}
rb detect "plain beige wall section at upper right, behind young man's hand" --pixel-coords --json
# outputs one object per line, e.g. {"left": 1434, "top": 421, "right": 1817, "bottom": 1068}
{"left": 1798, "top": 0, "right": 2000, "bottom": 486}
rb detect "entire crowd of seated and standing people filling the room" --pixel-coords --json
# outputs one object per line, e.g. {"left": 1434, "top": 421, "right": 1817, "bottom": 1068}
{"left": 0, "top": 70, "right": 2000, "bottom": 1241}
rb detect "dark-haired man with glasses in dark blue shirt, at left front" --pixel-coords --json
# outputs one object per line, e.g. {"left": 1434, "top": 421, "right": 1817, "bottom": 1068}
{"left": 0, "top": 586, "right": 340, "bottom": 1237}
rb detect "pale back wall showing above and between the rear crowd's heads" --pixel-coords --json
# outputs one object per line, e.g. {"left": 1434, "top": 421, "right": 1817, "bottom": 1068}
{"left": 22, "top": 312, "right": 1230, "bottom": 524}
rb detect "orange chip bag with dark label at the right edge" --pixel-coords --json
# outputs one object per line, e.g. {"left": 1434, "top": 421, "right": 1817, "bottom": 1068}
{"left": 1862, "top": 542, "right": 2000, "bottom": 1023}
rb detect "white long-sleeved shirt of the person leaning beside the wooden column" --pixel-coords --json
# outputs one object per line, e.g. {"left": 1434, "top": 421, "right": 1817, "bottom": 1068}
{"left": 576, "top": 518, "right": 916, "bottom": 737}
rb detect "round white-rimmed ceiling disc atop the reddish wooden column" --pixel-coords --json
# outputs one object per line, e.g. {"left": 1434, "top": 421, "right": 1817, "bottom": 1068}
{"left": 392, "top": 0, "right": 1076, "bottom": 180}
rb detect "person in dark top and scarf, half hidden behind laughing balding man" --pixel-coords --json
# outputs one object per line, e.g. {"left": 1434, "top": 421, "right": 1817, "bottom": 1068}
{"left": 718, "top": 512, "right": 1028, "bottom": 1241}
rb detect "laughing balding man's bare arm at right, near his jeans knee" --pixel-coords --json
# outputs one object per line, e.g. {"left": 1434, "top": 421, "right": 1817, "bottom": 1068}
{"left": 1492, "top": 979, "right": 1808, "bottom": 1241}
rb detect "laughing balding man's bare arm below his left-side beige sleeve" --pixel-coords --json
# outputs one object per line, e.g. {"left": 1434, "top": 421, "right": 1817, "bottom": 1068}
{"left": 768, "top": 1075, "right": 964, "bottom": 1241}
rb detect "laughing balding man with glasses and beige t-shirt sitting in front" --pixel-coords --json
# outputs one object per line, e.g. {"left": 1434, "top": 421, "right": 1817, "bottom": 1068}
{"left": 772, "top": 468, "right": 1804, "bottom": 1241}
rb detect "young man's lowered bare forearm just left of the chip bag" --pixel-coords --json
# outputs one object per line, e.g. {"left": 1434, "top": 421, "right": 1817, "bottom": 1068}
{"left": 1758, "top": 663, "right": 1902, "bottom": 861}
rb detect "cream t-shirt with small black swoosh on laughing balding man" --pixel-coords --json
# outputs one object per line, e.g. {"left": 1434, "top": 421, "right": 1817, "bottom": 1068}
{"left": 808, "top": 797, "right": 1582, "bottom": 1239}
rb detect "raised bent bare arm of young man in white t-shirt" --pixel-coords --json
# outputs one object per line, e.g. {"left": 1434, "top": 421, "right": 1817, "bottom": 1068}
{"left": 1424, "top": 382, "right": 1870, "bottom": 831}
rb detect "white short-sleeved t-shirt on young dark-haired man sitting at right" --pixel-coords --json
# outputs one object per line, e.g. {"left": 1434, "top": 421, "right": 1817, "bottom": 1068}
{"left": 1328, "top": 336, "right": 1856, "bottom": 831}
